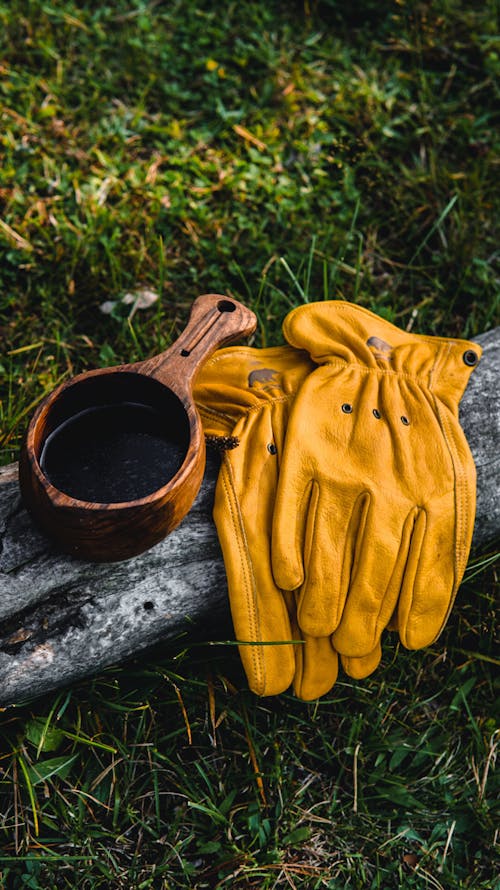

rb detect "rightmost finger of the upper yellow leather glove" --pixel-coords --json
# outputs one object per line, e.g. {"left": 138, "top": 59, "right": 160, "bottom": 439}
{"left": 397, "top": 492, "right": 461, "bottom": 649}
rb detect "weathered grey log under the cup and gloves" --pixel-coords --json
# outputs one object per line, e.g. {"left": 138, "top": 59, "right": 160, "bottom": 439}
{"left": 0, "top": 328, "right": 500, "bottom": 706}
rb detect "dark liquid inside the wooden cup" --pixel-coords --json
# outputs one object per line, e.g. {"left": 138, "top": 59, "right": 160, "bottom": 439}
{"left": 40, "top": 403, "right": 186, "bottom": 504}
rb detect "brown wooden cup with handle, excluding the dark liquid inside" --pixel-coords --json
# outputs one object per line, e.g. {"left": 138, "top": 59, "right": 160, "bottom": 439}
{"left": 19, "top": 294, "right": 256, "bottom": 562}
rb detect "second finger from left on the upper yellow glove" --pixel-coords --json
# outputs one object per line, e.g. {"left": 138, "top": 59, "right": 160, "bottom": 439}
{"left": 297, "top": 486, "right": 368, "bottom": 637}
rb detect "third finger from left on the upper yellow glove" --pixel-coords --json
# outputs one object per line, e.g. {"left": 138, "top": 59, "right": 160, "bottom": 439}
{"left": 333, "top": 502, "right": 417, "bottom": 657}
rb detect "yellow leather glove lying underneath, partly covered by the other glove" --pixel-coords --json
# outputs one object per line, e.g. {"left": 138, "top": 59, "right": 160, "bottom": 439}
{"left": 194, "top": 346, "right": 379, "bottom": 700}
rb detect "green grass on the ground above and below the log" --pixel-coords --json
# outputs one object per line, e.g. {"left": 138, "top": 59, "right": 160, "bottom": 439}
{"left": 0, "top": 0, "right": 500, "bottom": 890}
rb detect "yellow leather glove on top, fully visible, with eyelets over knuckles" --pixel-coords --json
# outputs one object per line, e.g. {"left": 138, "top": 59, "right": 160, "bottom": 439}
{"left": 272, "top": 301, "right": 481, "bottom": 657}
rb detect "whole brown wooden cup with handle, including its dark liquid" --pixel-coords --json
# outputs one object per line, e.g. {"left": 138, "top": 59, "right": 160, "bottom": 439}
{"left": 19, "top": 294, "right": 256, "bottom": 562}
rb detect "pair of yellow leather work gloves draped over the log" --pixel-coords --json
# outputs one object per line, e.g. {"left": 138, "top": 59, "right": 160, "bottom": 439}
{"left": 195, "top": 300, "right": 481, "bottom": 700}
